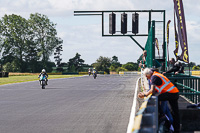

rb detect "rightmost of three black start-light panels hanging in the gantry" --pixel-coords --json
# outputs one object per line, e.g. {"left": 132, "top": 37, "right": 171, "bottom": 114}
{"left": 132, "top": 13, "right": 139, "bottom": 34}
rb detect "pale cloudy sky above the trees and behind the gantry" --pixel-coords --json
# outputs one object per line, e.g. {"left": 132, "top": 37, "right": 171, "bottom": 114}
{"left": 0, "top": 0, "right": 200, "bottom": 64}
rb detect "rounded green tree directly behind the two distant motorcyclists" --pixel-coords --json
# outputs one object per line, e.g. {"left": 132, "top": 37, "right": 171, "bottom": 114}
{"left": 93, "top": 56, "right": 112, "bottom": 73}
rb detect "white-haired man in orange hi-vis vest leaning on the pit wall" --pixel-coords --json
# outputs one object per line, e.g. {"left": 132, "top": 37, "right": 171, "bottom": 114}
{"left": 138, "top": 68, "right": 180, "bottom": 133}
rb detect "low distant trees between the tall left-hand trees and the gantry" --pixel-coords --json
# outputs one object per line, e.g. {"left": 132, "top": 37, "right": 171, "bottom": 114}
{"left": 60, "top": 53, "right": 138, "bottom": 74}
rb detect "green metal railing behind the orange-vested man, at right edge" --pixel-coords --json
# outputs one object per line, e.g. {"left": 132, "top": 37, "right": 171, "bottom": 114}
{"left": 166, "top": 74, "right": 200, "bottom": 104}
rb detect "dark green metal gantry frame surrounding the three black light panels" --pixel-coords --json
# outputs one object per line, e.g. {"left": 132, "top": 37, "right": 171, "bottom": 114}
{"left": 74, "top": 10, "right": 167, "bottom": 69}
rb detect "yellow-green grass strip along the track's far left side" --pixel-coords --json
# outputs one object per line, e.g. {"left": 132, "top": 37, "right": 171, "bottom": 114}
{"left": 0, "top": 75, "right": 82, "bottom": 85}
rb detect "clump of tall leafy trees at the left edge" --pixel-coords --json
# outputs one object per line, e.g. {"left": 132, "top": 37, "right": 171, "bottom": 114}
{"left": 0, "top": 13, "right": 62, "bottom": 72}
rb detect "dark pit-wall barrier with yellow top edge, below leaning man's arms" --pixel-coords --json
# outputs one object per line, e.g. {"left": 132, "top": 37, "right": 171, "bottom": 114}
{"left": 132, "top": 95, "right": 158, "bottom": 133}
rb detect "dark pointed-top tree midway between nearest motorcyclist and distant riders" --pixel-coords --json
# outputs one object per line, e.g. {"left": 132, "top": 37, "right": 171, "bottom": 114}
{"left": 68, "top": 53, "right": 85, "bottom": 72}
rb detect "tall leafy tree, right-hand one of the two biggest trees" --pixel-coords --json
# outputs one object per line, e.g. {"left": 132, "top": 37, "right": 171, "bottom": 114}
{"left": 29, "top": 13, "right": 63, "bottom": 67}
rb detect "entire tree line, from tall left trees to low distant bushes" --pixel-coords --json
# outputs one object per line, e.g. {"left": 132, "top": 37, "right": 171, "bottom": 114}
{"left": 0, "top": 13, "right": 138, "bottom": 73}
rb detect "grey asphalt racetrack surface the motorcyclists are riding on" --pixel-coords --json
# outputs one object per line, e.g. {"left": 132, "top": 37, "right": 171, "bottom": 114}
{"left": 0, "top": 75, "right": 139, "bottom": 133}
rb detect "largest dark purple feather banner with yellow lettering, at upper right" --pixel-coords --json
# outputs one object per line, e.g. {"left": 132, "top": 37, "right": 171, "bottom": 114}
{"left": 174, "top": 0, "right": 189, "bottom": 63}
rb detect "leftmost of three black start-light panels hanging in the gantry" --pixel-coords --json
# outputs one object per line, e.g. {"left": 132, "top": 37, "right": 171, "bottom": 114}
{"left": 109, "top": 13, "right": 116, "bottom": 34}
